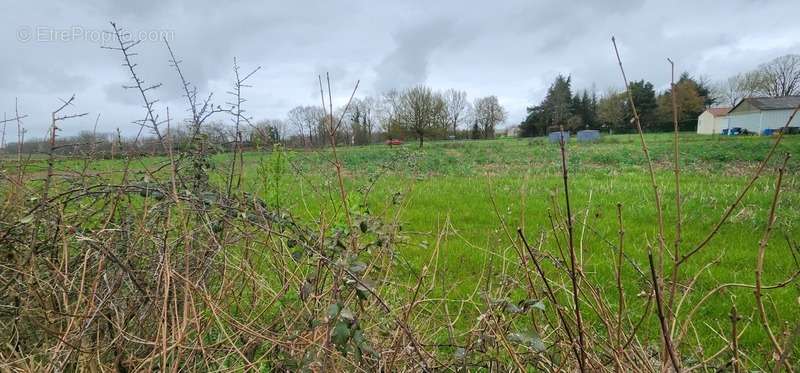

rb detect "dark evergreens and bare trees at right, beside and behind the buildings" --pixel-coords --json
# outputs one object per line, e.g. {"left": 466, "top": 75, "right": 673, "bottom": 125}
{"left": 519, "top": 55, "right": 800, "bottom": 137}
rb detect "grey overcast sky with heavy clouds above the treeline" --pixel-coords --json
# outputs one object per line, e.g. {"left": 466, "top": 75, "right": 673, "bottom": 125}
{"left": 0, "top": 0, "right": 800, "bottom": 141}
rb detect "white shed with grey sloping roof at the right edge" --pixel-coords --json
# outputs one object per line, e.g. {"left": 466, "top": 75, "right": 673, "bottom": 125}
{"left": 728, "top": 96, "right": 800, "bottom": 134}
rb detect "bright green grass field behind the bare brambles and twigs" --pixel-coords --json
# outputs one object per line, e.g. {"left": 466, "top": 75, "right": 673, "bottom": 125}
{"left": 7, "top": 134, "right": 800, "bottom": 363}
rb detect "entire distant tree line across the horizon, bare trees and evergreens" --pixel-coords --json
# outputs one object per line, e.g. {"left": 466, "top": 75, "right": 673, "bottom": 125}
{"left": 6, "top": 55, "right": 800, "bottom": 155}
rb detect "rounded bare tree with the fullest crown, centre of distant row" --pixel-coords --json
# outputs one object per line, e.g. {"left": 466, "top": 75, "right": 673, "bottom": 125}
{"left": 396, "top": 86, "right": 447, "bottom": 148}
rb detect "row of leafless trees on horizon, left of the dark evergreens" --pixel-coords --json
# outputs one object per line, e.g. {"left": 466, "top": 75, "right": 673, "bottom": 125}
{"left": 2, "top": 85, "right": 507, "bottom": 157}
